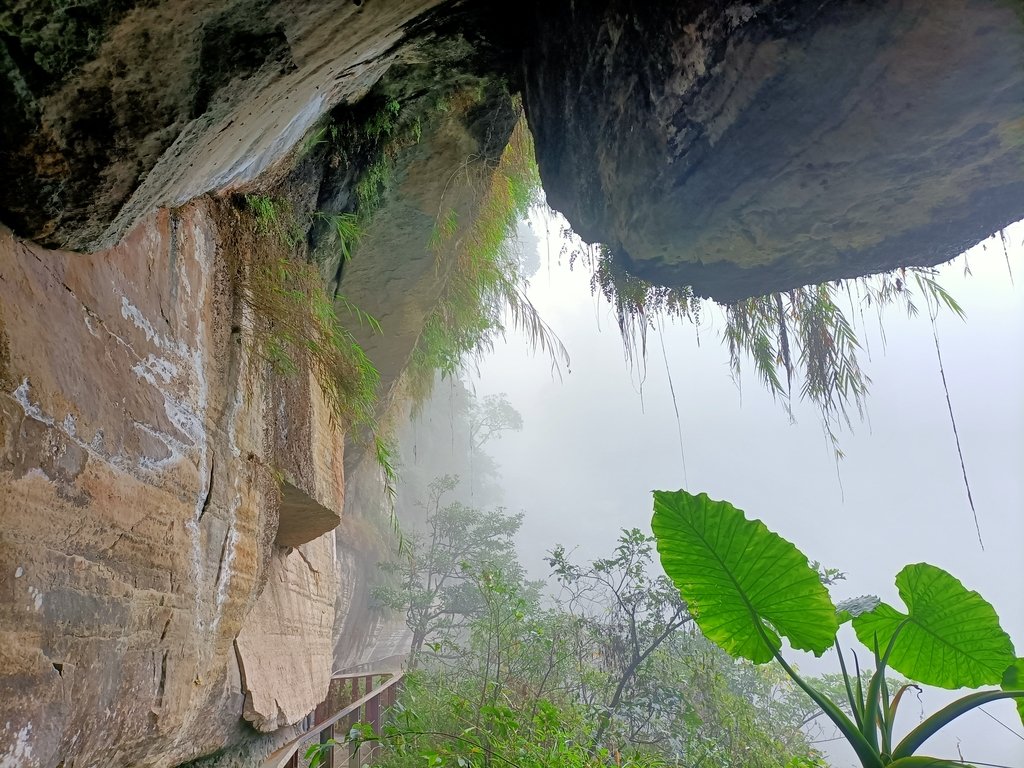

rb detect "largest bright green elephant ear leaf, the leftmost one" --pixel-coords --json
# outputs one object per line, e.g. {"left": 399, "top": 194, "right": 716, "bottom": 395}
{"left": 651, "top": 490, "right": 838, "bottom": 664}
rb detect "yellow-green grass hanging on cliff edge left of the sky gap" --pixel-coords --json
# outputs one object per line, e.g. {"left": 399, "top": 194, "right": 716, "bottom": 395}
{"left": 409, "top": 118, "right": 568, "bottom": 400}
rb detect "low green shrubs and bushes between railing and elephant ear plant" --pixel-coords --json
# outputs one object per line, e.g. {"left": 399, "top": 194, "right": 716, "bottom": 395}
{"left": 344, "top": 530, "right": 819, "bottom": 768}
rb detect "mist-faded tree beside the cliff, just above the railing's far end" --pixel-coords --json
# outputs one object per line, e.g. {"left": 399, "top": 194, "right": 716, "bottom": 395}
{"left": 374, "top": 475, "right": 522, "bottom": 668}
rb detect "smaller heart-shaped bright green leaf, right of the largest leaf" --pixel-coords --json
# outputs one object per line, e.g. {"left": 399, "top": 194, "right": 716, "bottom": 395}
{"left": 853, "top": 563, "right": 1016, "bottom": 688}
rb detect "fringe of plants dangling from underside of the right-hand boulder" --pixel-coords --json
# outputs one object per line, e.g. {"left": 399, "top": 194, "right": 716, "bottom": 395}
{"left": 569, "top": 246, "right": 965, "bottom": 457}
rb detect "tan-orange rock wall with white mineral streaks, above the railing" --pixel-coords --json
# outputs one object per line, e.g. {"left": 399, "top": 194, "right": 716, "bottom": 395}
{"left": 0, "top": 201, "right": 343, "bottom": 765}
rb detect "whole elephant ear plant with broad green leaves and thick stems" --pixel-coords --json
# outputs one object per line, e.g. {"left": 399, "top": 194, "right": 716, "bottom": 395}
{"left": 652, "top": 490, "right": 1024, "bottom": 768}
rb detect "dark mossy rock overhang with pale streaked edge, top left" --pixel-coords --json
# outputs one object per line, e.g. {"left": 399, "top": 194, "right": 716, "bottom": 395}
{"left": 0, "top": 0, "right": 439, "bottom": 250}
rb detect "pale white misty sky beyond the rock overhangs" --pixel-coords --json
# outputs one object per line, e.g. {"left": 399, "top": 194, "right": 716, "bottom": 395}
{"left": 462, "top": 210, "right": 1024, "bottom": 767}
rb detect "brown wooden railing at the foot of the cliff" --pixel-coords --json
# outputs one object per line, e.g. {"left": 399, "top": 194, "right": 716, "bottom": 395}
{"left": 262, "top": 672, "right": 404, "bottom": 768}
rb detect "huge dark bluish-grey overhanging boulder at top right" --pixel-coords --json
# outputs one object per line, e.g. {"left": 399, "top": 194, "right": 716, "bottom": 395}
{"left": 524, "top": 0, "right": 1024, "bottom": 301}
